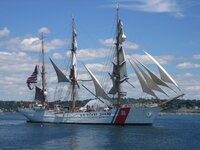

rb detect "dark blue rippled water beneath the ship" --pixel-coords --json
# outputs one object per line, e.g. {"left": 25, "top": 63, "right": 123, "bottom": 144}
{"left": 0, "top": 113, "right": 200, "bottom": 150}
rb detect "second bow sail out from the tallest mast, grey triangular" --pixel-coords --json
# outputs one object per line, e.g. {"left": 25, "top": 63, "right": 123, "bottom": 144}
{"left": 135, "top": 62, "right": 168, "bottom": 96}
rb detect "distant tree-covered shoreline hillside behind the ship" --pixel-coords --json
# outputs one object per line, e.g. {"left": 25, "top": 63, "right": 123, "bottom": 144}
{"left": 0, "top": 98, "right": 200, "bottom": 113}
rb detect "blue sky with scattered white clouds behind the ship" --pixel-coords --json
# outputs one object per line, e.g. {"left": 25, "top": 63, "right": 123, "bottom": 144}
{"left": 0, "top": 0, "right": 200, "bottom": 100}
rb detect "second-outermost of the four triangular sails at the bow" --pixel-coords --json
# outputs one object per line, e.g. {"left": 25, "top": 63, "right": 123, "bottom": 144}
{"left": 137, "top": 60, "right": 176, "bottom": 93}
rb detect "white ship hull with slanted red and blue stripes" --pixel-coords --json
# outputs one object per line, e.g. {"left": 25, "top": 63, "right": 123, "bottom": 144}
{"left": 20, "top": 106, "right": 161, "bottom": 125}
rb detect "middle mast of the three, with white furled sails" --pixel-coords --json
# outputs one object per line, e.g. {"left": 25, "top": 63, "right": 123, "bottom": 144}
{"left": 69, "top": 16, "right": 77, "bottom": 112}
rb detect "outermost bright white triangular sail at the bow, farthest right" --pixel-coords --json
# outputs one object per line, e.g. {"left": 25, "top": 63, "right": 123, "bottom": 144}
{"left": 144, "top": 51, "right": 178, "bottom": 88}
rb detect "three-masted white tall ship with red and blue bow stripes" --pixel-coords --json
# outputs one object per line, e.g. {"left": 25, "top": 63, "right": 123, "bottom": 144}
{"left": 19, "top": 7, "right": 184, "bottom": 125}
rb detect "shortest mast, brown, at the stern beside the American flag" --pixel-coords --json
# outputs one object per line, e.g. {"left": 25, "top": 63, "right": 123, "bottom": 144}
{"left": 41, "top": 33, "right": 46, "bottom": 104}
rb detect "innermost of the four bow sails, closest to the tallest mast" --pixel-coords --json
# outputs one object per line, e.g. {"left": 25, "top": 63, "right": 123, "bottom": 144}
{"left": 130, "top": 62, "right": 157, "bottom": 98}
